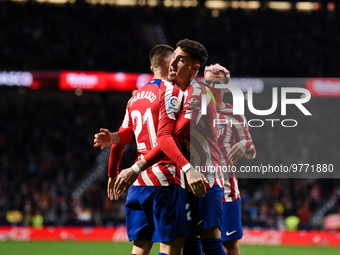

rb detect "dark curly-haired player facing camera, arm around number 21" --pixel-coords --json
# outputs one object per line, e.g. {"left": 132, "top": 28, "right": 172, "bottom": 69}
{"left": 114, "top": 39, "right": 225, "bottom": 255}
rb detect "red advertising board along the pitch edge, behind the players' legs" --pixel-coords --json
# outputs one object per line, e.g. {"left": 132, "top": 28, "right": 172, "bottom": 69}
{"left": 0, "top": 227, "right": 340, "bottom": 247}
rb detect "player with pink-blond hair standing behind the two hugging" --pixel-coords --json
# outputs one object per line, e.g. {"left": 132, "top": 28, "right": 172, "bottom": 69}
{"left": 204, "top": 64, "right": 256, "bottom": 255}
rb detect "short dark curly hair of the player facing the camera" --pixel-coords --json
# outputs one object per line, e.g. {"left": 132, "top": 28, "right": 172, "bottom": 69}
{"left": 177, "top": 39, "right": 208, "bottom": 66}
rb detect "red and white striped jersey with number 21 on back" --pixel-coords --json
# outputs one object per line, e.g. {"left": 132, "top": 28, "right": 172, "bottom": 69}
{"left": 122, "top": 79, "right": 185, "bottom": 188}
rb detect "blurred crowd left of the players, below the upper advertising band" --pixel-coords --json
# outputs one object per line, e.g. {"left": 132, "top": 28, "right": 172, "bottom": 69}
{"left": 0, "top": 88, "right": 135, "bottom": 224}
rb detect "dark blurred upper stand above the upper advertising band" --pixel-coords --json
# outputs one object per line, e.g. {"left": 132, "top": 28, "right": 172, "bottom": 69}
{"left": 0, "top": 1, "right": 340, "bottom": 77}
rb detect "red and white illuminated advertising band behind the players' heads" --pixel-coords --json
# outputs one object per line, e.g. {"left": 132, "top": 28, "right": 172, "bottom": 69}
{"left": 0, "top": 71, "right": 340, "bottom": 99}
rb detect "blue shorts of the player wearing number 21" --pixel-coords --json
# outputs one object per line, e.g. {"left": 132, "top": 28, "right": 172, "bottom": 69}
{"left": 125, "top": 184, "right": 192, "bottom": 242}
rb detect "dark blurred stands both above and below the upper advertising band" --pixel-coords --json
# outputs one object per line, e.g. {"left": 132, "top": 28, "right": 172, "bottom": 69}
{"left": 0, "top": 0, "right": 340, "bottom": 242}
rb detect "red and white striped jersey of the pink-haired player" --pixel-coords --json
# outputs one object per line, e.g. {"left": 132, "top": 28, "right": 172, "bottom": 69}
{"left": 217, "top": 104, "right": 256, "bottom": 202}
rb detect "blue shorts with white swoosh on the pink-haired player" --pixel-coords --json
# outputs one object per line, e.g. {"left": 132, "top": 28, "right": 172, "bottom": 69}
{"left": 221, "top": 198, "right": 243, "bottom": 242}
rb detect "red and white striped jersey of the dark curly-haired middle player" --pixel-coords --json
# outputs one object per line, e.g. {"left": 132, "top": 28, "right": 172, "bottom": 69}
{"left": 178, "top": 79, "right": 223, "bottom": 188}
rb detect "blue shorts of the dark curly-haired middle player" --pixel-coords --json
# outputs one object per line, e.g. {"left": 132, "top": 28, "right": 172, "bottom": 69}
{"left": 189, "top": 185, "right": 223, "bottom": 235}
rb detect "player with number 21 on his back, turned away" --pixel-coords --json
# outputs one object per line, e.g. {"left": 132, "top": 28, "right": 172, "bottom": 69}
{"left": 94, "top": 45, "right": 192, "bottom": 255}
